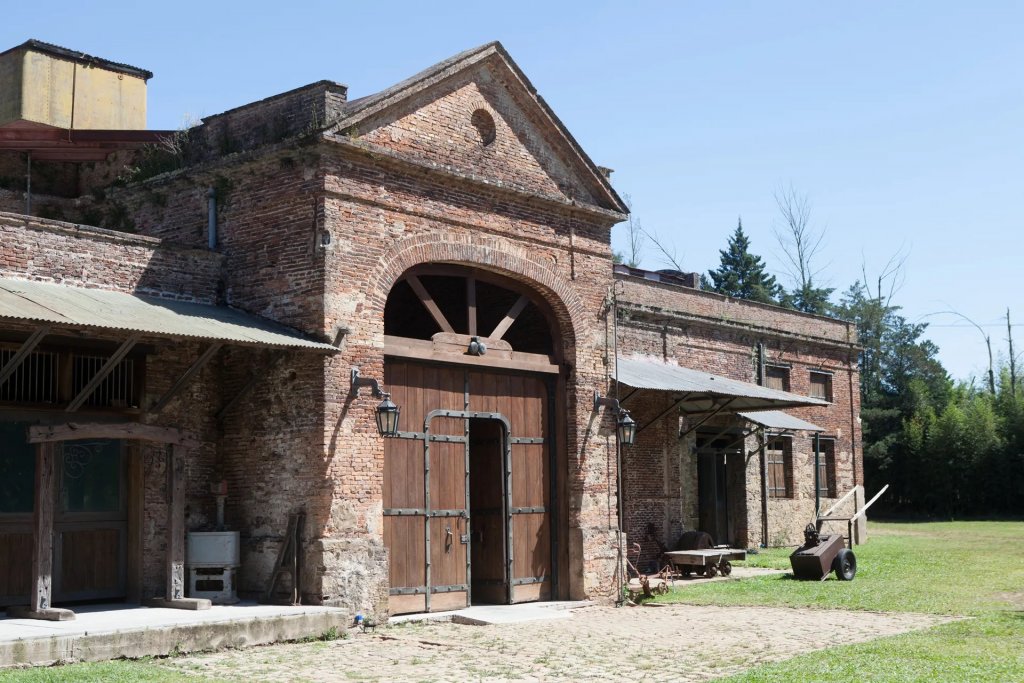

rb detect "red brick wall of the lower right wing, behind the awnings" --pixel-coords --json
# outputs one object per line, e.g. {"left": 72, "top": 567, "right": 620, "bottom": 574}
{"left": 616, "top": 275, "right": 863, "bottom": 548}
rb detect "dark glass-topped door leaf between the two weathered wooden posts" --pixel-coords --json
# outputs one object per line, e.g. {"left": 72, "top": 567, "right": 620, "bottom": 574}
{"left": 53, "top": 439, "right": 128, "bottom": 602}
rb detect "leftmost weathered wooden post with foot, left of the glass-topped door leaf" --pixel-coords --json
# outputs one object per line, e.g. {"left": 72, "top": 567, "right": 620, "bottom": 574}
{"left": 7, "top": 443, "right": 75, "bottom": 622}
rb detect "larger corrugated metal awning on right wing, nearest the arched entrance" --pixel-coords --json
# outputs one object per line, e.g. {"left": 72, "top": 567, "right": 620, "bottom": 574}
{"left": 616, "top": 358, "right": 828, "bottom": 414}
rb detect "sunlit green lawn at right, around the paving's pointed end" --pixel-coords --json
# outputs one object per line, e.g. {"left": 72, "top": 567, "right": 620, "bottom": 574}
{"left": 658, "top": 521, "right": 1024, "bottom": 683}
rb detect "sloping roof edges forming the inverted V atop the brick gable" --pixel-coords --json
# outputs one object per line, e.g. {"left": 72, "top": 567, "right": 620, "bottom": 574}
{"left": 333, "top": 41, "right": 629, "bottom": 214}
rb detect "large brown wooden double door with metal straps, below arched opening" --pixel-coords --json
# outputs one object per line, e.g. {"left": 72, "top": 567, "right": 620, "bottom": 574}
{"left": 384, "top": 359, "right": 558, "bottom": 613}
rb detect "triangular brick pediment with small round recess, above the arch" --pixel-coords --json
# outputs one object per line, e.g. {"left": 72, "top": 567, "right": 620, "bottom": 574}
{"left": 333, "top": 43, "right": 626, "bottom": 213}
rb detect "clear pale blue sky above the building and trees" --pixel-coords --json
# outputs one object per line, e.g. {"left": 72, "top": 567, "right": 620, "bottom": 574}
{"left": 6, "top": 0, "right": 1024, "bottom": 378}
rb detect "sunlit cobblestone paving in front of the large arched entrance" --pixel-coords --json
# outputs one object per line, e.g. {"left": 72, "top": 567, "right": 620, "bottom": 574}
{"left": 168, "top": 605, "right": 950, "bottom": 683}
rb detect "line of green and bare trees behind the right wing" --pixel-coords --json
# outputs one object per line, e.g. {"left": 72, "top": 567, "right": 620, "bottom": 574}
{"left": 616, "top": 187, "right": 1024, "bottom": 517}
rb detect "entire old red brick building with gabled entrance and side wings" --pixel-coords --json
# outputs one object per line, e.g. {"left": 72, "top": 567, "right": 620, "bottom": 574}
{"left": 0, "top": 41, "right": 862, "bottom": 613}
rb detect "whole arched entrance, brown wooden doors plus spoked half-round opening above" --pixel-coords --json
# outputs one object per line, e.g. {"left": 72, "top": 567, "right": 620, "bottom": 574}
{"left": 382, "top": 260, "right": 569, "bottom": 613}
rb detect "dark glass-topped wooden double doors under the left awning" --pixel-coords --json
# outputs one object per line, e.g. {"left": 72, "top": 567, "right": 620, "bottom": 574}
{"left": 0, "top": 423, "right": 128, "bottom": 605}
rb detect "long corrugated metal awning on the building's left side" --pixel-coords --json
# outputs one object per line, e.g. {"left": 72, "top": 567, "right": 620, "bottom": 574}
{"left": 0, "top": 279, "right": 337, "bottom": 353}
